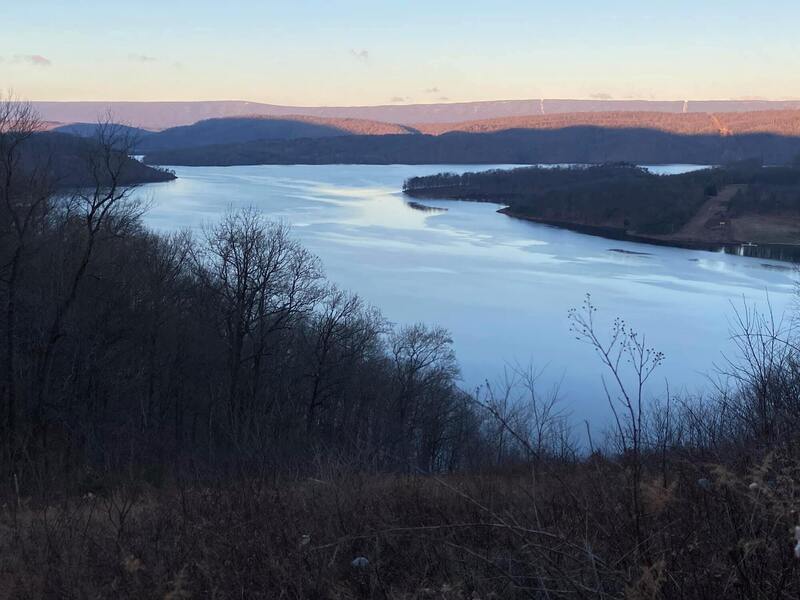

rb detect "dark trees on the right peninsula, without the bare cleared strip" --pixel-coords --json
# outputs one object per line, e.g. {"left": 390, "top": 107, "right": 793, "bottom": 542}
{"left": 403, "top": 159, "right": 800, "bottom": 235}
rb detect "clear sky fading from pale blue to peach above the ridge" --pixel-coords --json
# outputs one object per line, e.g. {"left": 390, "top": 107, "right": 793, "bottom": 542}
{"left": 0, "top": 0, "right": 800, "bottom": 106}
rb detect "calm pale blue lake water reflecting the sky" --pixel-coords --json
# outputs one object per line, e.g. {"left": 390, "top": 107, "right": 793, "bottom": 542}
{"left": 142, "top": 165, "right": 795, "bottom": 420}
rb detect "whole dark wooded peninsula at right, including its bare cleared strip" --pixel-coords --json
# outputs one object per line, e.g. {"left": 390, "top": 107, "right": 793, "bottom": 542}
{"left": 404, "top": 161, "right": 800, "bottom": 244}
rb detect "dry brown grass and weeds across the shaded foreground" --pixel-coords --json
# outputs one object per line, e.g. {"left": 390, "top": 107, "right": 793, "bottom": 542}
{"left": 0, "top": 456, "right": 800, "bottom": 600}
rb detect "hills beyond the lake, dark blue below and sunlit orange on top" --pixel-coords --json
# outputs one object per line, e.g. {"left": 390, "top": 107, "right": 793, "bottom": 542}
{"left": 37, "top": 105, "right": 800, "bottom": 165}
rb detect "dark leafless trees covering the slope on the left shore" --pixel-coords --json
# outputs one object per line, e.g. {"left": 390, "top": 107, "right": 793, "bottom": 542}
{"left": 0, "top": 105, "right": 478, "bottom": 478}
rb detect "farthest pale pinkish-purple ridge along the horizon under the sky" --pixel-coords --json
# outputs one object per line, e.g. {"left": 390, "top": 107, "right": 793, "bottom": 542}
{"left": 33, "top": 99, "right": 800, "bottom": 129}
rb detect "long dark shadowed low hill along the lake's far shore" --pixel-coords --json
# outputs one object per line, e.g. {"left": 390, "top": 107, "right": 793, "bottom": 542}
{"left": 145, "top": 126, "right": 800, "bottom": 166}
